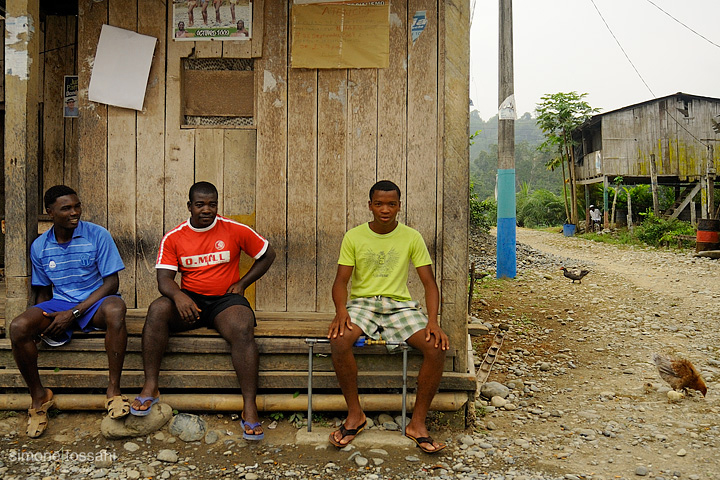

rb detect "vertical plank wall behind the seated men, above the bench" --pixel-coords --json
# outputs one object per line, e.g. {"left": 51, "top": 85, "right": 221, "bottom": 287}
{"left": 11, "top": 0, "right": 469, "bottom": 369}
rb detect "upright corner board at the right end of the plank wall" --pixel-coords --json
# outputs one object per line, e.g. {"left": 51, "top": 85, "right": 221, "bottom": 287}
{"left": 439, "top": 2, "right": 470, "bottom": 372}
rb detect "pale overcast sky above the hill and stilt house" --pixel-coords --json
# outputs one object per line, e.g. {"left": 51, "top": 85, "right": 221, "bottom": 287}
{"left": 470, "top": 0, "right": 720, "bottom": 119}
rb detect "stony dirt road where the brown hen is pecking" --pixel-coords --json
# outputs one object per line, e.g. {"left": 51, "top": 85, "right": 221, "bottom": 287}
{"left": 474, "top": 229, "right": 720, "bottom": 479}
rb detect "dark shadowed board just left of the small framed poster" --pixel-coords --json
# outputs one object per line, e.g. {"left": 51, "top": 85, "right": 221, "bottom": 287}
{"left": 40, "top": 15, "right": 67, "bottom": 192}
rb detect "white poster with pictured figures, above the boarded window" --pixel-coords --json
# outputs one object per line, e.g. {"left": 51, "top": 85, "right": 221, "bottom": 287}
{"left": 172, "top": 0, "right": 252, "bottom": 42}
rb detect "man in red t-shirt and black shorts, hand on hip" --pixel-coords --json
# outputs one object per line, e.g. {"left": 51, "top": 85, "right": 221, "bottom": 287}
{"left": 130, "top": 182, "right": 275, "bottom": 440}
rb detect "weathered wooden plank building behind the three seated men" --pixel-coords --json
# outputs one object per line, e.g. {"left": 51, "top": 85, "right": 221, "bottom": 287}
{"left": 0, "top": 0, "right": 475, "bottom": 411}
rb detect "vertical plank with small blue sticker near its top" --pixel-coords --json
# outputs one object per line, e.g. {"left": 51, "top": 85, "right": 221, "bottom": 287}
{"left": 405, "top": 0, "right": 438, "bottom": 300}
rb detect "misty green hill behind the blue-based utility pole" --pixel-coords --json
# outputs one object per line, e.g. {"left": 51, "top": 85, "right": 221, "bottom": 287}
{"left": 470, "top": 110, "right": 562, "bottom": 200}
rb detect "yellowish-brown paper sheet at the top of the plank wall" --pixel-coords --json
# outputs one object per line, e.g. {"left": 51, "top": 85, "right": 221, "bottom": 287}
{"left": 291, "top": 1, "right": 390, "bottom": 68}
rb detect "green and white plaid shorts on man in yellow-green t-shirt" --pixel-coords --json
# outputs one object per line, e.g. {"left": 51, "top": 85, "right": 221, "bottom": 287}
{"left": 347, "top": 296, "right": 428, "bottom": 350}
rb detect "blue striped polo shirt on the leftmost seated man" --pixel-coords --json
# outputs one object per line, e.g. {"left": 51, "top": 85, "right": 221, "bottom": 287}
{"left": 30, "top": 221, "right": 125, "bottom": 303}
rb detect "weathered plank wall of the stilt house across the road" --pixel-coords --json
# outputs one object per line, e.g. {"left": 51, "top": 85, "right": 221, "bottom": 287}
{"left": 576, "top": 94, "right": 720, "bottom": 183}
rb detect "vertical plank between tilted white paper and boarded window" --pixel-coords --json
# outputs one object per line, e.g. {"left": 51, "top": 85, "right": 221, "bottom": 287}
{"left": 163, "top": 8, "right": 195, "bottom": 232}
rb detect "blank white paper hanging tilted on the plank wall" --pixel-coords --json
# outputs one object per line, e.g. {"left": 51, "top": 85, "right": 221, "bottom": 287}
{"left": 88, "top": 25, "right": 157, "bottom": 110}
